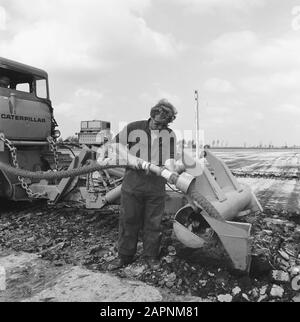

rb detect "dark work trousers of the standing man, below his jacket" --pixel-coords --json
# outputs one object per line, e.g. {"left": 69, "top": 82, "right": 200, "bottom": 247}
{"left": 119, "top": 190, "right": 165, "bottom": 257}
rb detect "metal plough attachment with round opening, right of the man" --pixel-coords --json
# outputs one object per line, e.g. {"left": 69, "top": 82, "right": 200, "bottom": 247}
{"left": 174, "top": 151, "right": 263, "bottom": 272}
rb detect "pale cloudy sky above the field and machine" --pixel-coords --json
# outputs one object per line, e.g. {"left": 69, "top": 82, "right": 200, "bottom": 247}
{"left": 0, "top": 0, "right": 300, "bottom": 146}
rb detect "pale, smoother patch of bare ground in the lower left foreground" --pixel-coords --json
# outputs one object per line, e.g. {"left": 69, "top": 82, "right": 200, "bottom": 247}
{"left": 0, "top": 252, "right": 198, "bottom": 302}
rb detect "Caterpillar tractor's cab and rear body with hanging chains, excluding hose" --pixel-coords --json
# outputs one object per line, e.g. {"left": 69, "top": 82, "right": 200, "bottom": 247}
{"left": 0, "top": 58, "right": 71, "bottom": 201}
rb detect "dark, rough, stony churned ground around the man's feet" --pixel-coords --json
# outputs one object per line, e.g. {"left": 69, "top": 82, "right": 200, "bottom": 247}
{"left": 0, "top": 190, "right": 300, "bottom": 302}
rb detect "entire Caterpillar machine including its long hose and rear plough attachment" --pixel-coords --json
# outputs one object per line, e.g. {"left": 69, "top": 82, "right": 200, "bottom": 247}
{"left": 0, "top": 58, "right": 263, "bottom": 272}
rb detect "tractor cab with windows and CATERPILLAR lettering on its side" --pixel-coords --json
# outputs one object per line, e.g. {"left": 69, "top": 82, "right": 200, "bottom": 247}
{"left": 0, "top": 58, "right": 53, "bottom": 141}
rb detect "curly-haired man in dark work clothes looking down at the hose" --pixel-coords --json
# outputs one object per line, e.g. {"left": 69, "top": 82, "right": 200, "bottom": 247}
{"left": 108, "top": 100, "right": 177, "bottom": 270}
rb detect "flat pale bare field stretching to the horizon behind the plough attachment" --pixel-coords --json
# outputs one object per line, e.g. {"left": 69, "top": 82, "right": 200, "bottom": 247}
{"left": 213, "top": 149, "right": 300, "bottom": 214}
